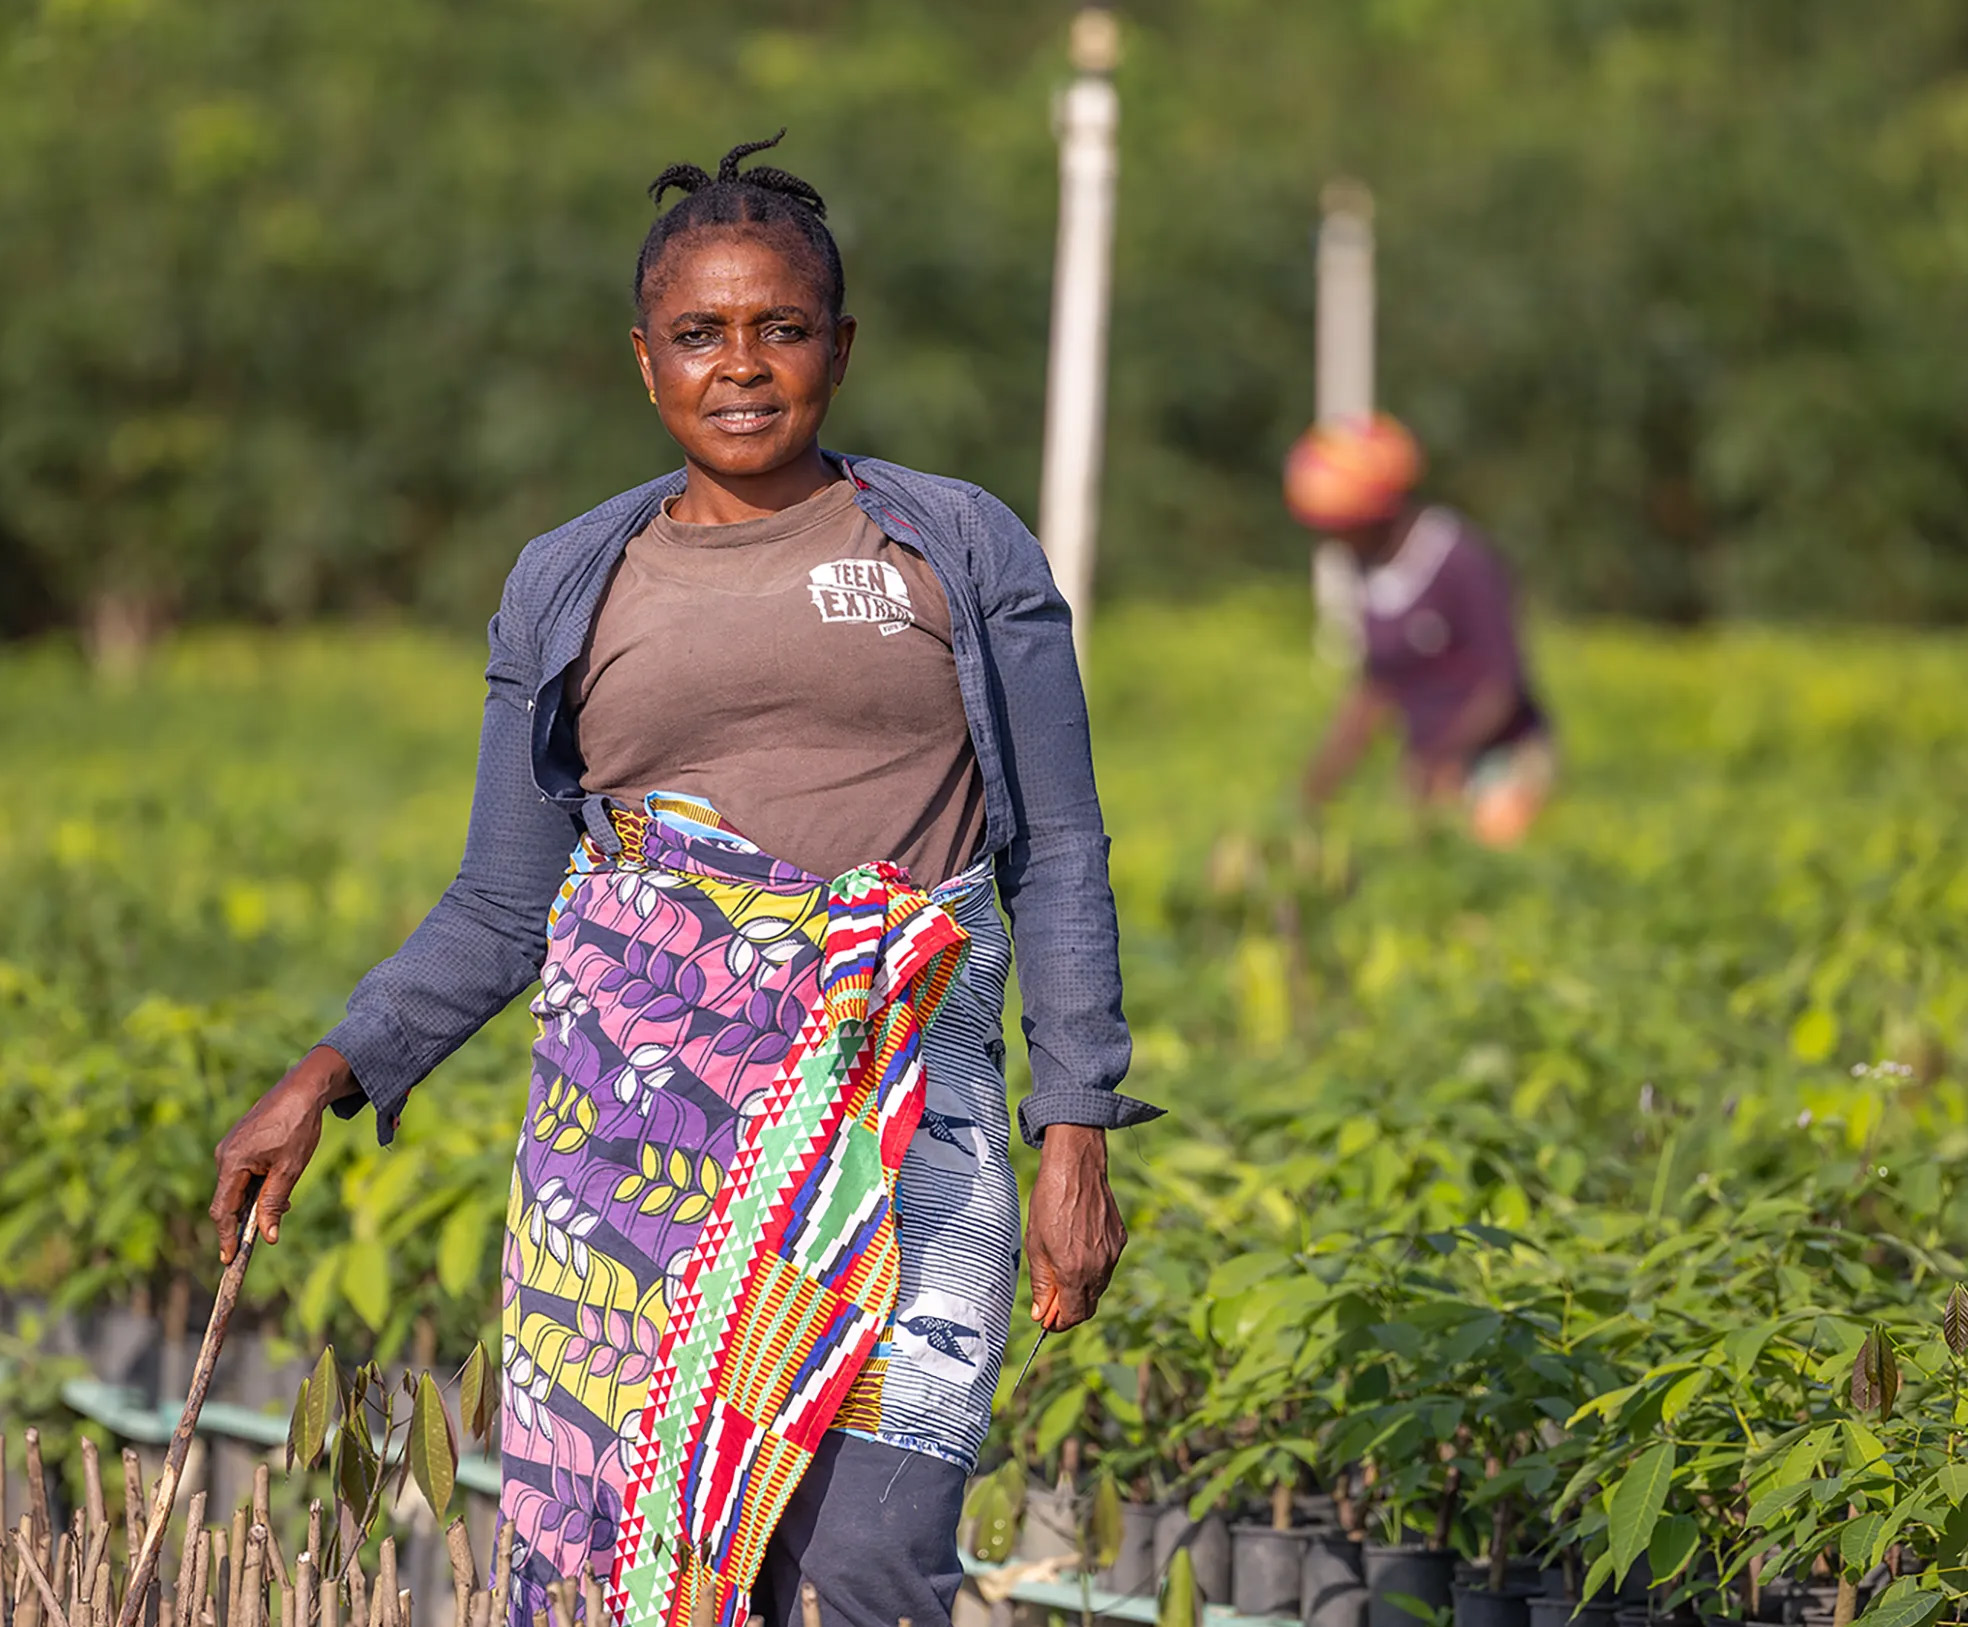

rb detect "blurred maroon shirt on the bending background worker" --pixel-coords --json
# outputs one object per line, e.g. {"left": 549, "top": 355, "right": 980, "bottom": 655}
{"left": 1360, "top": 508, "right": 1545, "bottom": 757}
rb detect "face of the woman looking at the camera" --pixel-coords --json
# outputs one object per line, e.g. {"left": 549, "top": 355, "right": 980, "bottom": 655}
{"left": 634, "top": 228, "right": 854, "bottom": 480}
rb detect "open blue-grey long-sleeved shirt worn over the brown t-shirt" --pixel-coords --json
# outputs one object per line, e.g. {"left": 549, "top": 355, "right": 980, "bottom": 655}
{"left": 325, "top": 454, "right": 1159, "bottom": 1143}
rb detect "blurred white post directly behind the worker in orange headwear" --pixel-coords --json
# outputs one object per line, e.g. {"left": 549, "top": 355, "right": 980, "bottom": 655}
{"left": 1313, "top": 181, "right": 1374, "bottom": 667}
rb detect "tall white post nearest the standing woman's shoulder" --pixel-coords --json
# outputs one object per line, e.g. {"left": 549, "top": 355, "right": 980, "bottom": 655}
{"left": 1039, "top": 6, "right": 1120, "bottom": 667}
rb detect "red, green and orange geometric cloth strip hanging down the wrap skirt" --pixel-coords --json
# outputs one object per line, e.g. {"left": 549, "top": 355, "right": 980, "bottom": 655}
{"left": 608, "top": 864, "right": 964, "bottom": 1627}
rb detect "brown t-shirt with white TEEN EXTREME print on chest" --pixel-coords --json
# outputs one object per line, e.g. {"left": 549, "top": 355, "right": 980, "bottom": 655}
{"left": 567, "top": 480, "right": 984, "bottom": 887}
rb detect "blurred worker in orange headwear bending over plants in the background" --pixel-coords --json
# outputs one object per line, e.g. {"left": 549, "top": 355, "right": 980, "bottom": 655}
{"left": 1285, "top": 415, "right": 1553, "bottom": 846}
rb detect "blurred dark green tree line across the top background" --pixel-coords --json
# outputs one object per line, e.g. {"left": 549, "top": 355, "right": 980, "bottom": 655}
{"left": 0, "top": 0, "right": 1968, "bottom": 635}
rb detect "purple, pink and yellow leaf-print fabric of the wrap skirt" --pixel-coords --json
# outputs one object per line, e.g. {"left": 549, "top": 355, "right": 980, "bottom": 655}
{"left": 500, "top": 806, "right": 827, "bottom": 1623}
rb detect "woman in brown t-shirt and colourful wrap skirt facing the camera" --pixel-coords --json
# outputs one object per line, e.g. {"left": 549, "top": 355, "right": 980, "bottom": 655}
{"left": 213, "top": 132, "right": 1155, "bottom": 1627}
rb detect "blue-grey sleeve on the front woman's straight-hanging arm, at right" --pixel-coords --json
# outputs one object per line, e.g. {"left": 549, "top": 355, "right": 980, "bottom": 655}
{"left": 972, "top": 492, "right": 1161, "bottom": 1145}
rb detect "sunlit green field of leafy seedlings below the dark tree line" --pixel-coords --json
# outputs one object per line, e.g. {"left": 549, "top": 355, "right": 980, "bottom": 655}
{"left": 0, "top": 592, "right": 1968, "bottom": 1613}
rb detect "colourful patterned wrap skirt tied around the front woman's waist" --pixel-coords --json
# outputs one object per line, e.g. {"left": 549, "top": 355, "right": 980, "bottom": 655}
{"left": 500, "top": 795, "right": 1017, "bottom": 1627}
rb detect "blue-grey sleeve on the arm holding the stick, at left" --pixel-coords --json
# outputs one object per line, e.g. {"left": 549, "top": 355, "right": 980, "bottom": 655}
{"left": 323, "top": 571, "right": 579, "bottom": 1141}
